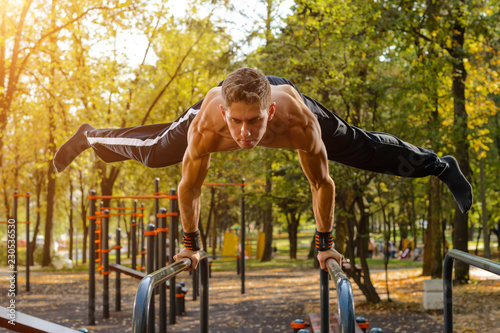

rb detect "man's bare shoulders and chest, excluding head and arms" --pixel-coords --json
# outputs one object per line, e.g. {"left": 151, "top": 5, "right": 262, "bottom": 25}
{"left": 188, "top": 85, "right": 322, "bottom": 156}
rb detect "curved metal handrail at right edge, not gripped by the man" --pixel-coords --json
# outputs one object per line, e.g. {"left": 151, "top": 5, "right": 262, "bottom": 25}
{"left": 443, "top": 249, "right": 500, "bottom": 333}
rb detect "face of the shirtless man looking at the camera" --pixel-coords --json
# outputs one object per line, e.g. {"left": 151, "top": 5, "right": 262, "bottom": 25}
{"left": 220, "top": 102, "right": 276, "bottom": 149}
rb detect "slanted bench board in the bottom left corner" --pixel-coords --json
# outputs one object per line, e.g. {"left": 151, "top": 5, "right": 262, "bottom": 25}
{"left": 0, "top": 306, "right": 85, "bottom": 333}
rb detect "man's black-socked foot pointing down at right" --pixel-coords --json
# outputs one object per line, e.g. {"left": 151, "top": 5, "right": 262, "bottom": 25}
{"left": 437, "top": 156, "right": 472, "bottom": 214}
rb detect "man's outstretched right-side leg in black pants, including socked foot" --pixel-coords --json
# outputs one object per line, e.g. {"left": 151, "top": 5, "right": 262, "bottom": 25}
{"left": 303, "top": 95, "right": 472, "bottom": 214}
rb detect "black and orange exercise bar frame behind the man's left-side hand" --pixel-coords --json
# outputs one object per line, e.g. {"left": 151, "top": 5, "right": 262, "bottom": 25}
{"left": 87, "top": 178, "right": 179, "bottom": 325}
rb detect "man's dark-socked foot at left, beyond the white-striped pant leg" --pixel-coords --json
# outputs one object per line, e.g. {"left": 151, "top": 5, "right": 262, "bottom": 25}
{"left": 54, "top": 124, "right": 94, "bottom": 172}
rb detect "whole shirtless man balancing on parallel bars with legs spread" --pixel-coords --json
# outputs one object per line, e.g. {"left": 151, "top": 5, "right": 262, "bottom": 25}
{"left": 54, "top": 68, "right": 472, "bottom": 269}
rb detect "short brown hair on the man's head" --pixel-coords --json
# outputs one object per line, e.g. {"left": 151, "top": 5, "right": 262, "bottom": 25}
{"left": 221, "top": 67, "right": 271, "bottom": 109}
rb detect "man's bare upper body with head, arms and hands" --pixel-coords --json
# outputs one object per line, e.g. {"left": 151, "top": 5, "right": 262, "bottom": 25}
{"left": 175, "top": 68, "right": 341, "bottom": 269}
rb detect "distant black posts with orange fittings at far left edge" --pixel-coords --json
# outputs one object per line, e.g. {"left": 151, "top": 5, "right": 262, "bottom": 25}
{"left": 0, "top": 190, "right": 31, "bottom": 295}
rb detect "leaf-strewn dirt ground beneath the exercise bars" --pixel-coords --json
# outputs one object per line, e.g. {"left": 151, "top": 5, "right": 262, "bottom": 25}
{"left": 0, "top": 269, "right": 500, "bottom": 333}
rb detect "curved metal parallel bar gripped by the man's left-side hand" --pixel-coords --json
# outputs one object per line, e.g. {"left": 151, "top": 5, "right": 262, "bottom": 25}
{"left": 132, "top": 251, "right": 208, "bottom": 333}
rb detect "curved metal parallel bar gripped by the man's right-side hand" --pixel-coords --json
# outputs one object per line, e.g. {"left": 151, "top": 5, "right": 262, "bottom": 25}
{"left": 320, "top": 259, "right": 356, "bottom": 333}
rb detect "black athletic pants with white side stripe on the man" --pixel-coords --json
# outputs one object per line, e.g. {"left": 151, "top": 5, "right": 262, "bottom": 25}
{"left": 87, "top": 76, "right": 440, "bottom": 177}
